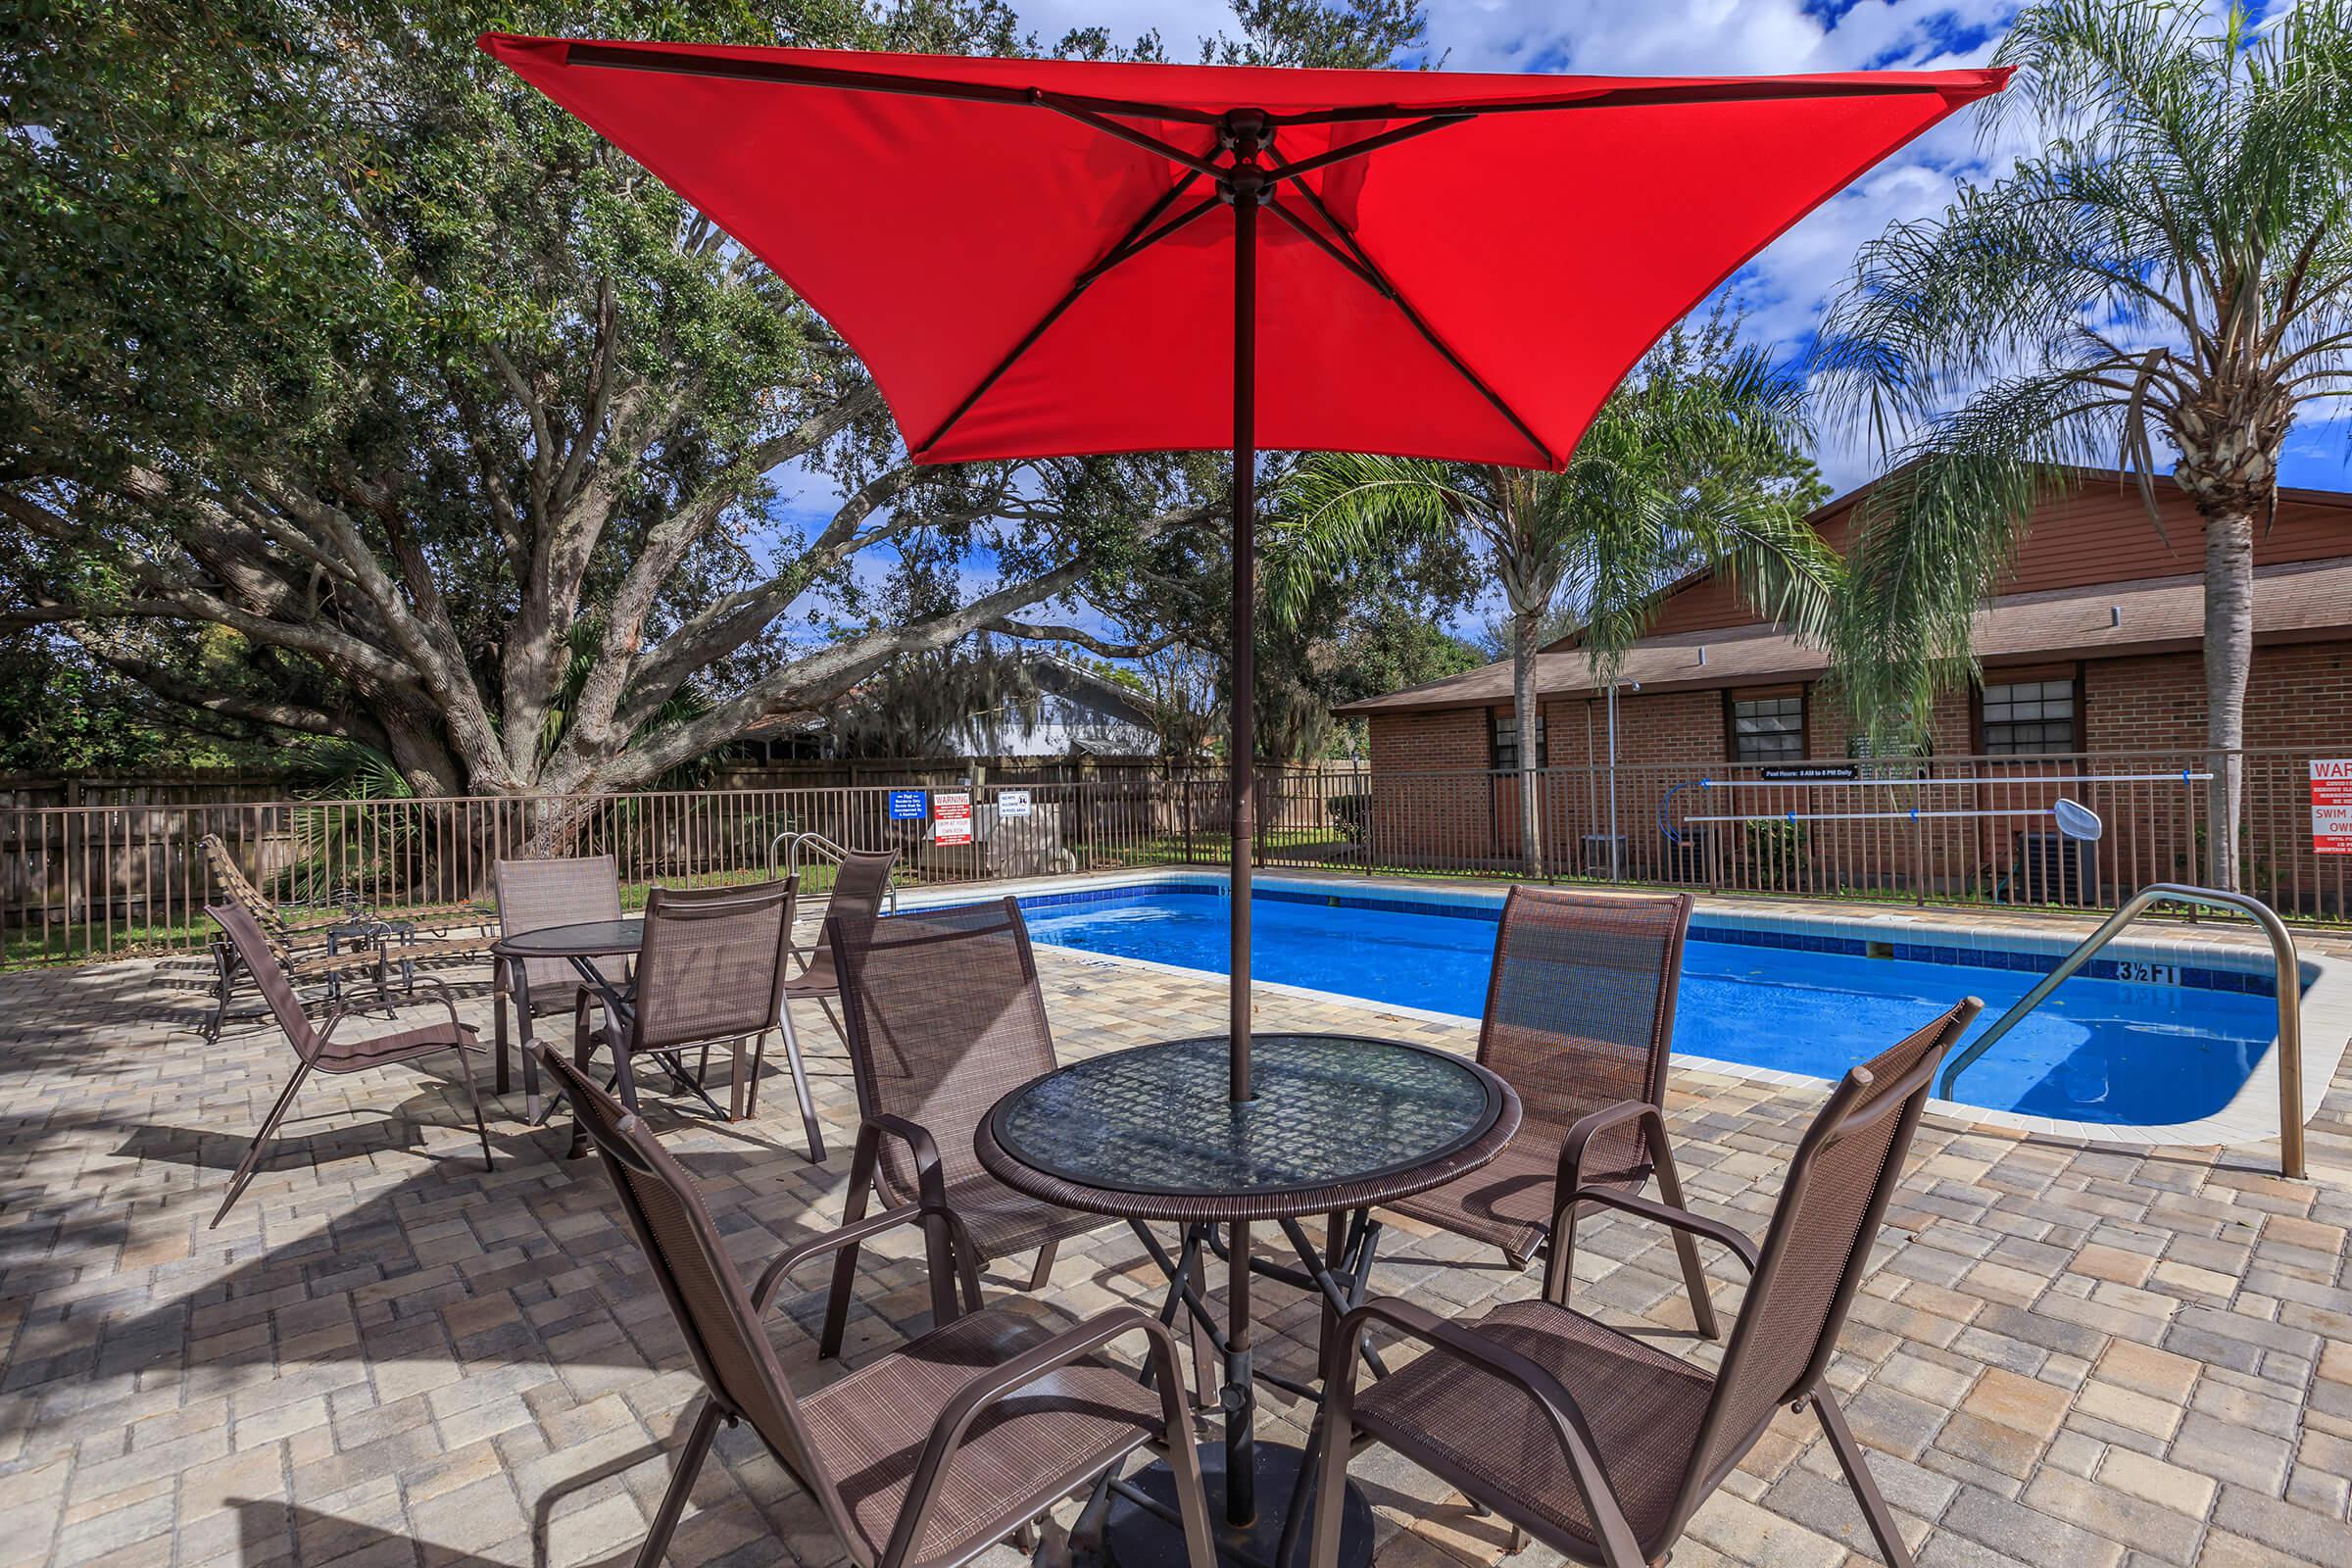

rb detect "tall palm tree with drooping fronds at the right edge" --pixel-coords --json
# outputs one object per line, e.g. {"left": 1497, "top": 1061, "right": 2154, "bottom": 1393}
{"left": 1816, "top": 0, "right": 2352, "bottom": 886}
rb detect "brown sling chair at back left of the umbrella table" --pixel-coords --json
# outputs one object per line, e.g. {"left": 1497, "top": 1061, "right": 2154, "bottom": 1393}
{"left": 821, "top": 898, "right": 1117, "bottom": 1356}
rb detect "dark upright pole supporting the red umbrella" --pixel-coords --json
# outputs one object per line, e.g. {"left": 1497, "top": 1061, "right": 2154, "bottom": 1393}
{"left": 1225, "top": 166, "right": 1258, "bottom": 1102}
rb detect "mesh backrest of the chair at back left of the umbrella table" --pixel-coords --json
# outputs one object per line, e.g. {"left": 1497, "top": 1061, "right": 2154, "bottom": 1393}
{"left": 825, "top": 898, "right": 1056, "bottom": 1201}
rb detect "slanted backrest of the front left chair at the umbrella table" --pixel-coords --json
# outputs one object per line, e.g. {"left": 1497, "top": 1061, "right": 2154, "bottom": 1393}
{"left": 539, "top": 1049, "right": 840, "bottom": 1519}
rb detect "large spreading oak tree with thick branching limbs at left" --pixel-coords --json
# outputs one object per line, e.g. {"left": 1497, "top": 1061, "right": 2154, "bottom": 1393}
{"left": 0, "top": 0, "right": 1223, "bottom": 795}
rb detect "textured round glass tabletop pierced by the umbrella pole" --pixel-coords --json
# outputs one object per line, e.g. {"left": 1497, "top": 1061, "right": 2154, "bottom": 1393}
{"left": 990, "top": 1034, "right": 1510, "bottom": 1199}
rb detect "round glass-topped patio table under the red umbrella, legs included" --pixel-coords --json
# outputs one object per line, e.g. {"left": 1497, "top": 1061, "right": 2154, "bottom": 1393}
{"left": 974, "top": 1034, "right": 1519, "bottom": 1568}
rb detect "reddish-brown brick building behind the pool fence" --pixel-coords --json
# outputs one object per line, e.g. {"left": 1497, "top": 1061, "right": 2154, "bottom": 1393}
{"left": 1339, "top": 472, "right": 2352, "bottom": 906}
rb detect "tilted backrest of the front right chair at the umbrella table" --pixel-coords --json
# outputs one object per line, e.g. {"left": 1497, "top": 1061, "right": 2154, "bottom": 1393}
{"left": 1684, "top": 997, "right": 1985, "bottom": 1516}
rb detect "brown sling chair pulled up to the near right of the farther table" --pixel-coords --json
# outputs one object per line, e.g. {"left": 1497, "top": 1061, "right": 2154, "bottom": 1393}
{"left": 568, "top": 877, "right": 793, "bottom": 1152}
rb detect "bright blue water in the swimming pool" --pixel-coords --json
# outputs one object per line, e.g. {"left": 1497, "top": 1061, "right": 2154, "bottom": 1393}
{"left": 1023, "top": 882, "right": 2279, "bottom": 1126}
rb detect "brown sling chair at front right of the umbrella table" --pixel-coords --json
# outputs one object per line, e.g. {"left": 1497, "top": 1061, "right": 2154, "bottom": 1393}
{"left": 1312, "top": 997, "right": 1983, "bottom": 1568}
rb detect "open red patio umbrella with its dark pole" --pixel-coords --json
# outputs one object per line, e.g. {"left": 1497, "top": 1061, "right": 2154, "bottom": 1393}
{"left": 482, "top": 33, "right": 2006, "bottom": 1101}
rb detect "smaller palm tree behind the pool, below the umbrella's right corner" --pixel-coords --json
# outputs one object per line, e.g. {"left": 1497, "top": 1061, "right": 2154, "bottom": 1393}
{"left": 1268, "top": 350, "right": 1839, "bottom": 877}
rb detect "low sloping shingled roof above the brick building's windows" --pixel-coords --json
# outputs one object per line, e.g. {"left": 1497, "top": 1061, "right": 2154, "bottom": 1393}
{"left": 1334, "top": 558, "right": 2352, "bottom": 714}
